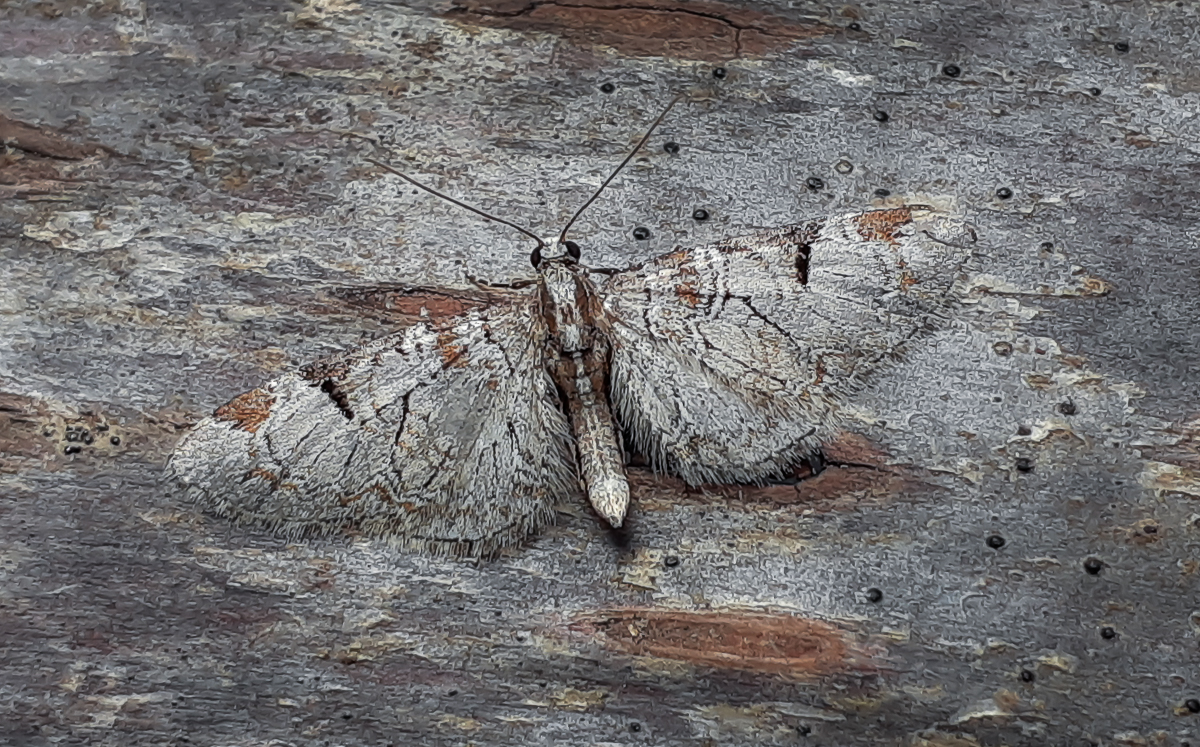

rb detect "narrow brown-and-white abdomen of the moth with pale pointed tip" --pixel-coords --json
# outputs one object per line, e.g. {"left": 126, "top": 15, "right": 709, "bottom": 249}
{"left": 554, "top": 348, "right": 629, "bottom": 527}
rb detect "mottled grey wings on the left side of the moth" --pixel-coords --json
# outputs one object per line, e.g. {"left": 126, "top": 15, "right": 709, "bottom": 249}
{"left": 170, "top": 288, "right": 576, "bottom": 556}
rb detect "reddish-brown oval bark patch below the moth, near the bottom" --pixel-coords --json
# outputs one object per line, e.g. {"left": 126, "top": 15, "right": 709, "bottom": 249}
{"left": 571, "top": 609, "right": 864, "bottom": 677}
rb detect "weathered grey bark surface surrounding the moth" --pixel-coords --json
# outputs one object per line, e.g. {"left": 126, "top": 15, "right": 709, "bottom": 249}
{"left": 0, "top": 0, "right": 1200, "bottom": 746}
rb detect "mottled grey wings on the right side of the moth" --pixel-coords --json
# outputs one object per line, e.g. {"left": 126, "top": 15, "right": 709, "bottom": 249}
{"left": 601, "top": 208, "right": 966, "bottom": 484}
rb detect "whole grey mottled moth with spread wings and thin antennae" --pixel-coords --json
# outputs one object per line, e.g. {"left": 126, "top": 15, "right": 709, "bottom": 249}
{"left": 169, "top": 107, "right": 966, "bottom": 557}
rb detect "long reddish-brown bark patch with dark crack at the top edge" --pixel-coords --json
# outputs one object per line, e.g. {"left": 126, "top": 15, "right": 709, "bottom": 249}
{"left": 446, "top": 0, "right": 833, "bottom": 62}
